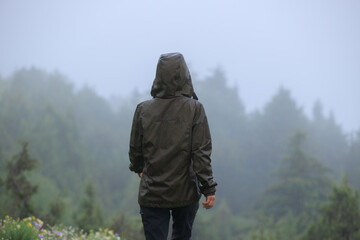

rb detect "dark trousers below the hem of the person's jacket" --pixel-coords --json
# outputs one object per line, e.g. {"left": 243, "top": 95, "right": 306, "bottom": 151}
{"left": 140, "top": 202, "right": 199, "bottom": 240}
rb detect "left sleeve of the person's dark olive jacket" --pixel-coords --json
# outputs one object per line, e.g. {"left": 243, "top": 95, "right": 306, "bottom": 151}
{"left": 129, "top": 104, "right": 144, "bottom": 173}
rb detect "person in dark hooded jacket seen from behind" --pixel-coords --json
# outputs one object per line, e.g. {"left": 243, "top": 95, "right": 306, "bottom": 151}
{"left": 129, "top": 53, "right": 217, "bottom": 240}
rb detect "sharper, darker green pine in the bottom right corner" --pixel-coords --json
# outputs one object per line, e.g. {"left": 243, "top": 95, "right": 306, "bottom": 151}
{"left": 304, "top": 176, "right": 360, "bottom": 240}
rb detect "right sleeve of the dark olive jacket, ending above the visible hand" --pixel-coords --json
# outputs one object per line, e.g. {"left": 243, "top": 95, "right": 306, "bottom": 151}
{"left": 191, "top": 102, "right": 217, "bottom": 196}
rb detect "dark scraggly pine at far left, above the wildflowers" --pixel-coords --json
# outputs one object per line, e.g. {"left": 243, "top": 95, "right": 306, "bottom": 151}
{"left": 5, "top": 142, "right": 38, "bottom": 218}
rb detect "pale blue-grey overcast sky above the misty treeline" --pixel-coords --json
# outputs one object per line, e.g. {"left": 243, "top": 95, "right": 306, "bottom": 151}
{"left": 0, "top": 0, "right": 360, "bottom": 132}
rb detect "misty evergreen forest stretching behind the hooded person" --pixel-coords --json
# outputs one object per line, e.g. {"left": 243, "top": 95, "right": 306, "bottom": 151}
{"left": 0, "top": 68, "right": 360, "bottom": 240}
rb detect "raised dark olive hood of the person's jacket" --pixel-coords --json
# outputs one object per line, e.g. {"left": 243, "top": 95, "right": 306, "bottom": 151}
{"left": 151, "top": 53, "right": 198, "bottom": 100}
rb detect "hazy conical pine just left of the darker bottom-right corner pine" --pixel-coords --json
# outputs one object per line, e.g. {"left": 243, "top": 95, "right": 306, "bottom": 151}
{"left": 257, "top": 131, "right": 330, "bottom": 224}
